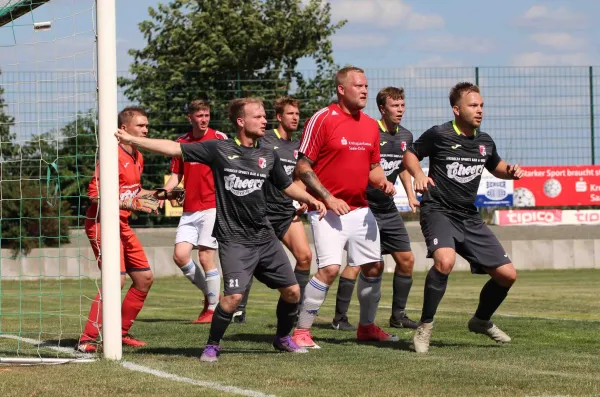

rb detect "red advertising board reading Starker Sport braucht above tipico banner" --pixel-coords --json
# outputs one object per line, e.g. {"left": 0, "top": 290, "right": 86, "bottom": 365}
{"left": 514, "top": 165, "right": 600, "bottom": 207}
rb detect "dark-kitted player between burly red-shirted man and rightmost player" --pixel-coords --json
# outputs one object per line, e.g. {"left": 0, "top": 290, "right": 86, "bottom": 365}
{"left": 331, "top": 87, "right": 419, "bottom": 331}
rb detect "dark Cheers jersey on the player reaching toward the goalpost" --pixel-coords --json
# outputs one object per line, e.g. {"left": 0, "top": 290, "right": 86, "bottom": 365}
{"left": 181, "top": 139, "right": 292, "bottom": 245}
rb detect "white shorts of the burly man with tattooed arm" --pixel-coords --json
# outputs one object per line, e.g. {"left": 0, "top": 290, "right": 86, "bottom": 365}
{"left": 309, "top": 208, "right": 381, "bottom": 269}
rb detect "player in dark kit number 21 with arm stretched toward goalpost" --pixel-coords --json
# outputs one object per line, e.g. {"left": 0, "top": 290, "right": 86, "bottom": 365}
{"left": 115, "top": 98, "right": 327, "bottom": 362}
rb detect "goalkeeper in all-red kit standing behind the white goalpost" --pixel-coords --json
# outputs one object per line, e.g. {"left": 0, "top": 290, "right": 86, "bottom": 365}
{"left": 76, "top": 107, "right": 164, "bottom": 353}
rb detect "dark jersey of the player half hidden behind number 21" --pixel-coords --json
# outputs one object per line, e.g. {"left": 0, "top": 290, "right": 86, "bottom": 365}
{"left": 259, "top": 129, "right": 300, "bottom": 217}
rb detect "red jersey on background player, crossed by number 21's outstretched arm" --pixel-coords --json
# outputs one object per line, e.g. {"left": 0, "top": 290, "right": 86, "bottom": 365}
{"left": 171, "top": 128, "right": 227, "bottom": 212}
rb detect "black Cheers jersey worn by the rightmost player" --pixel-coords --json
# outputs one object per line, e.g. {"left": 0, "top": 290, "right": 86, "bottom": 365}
{"left": 409, "top": 121, "right": 501, "bottom": 216}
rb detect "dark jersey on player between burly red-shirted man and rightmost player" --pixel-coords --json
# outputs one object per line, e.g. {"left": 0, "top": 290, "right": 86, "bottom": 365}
{"left": 367, "top": 121, "right": 413, "bottom": 212}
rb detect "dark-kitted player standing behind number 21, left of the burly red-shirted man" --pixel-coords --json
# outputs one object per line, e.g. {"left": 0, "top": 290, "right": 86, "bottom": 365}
{"left": 233, "top": 96, "right": 312, "bottom": 323}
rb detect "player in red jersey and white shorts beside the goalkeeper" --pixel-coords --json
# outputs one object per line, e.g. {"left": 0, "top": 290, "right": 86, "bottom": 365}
{"left": 164, "top": 100, "right": 227, "bottom": 324}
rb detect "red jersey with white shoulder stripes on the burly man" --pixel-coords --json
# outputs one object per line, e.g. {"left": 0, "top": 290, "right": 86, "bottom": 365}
{"left": 300, "top": 104, "right": 379, "bottom": 209}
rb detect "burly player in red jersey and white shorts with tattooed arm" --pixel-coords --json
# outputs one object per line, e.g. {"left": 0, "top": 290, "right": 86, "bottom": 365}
{"left": 293, "top": 67, "right": 398, "bottom": 348}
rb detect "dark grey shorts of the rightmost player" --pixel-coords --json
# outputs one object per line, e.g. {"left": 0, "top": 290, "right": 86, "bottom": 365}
{"left": 421, "top": 211, "right": 511, "bottom": 274}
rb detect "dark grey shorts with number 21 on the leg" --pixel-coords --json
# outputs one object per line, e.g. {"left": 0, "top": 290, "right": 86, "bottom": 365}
{"left": 219, "top": 239, "right": 298, "bottom": 295}
